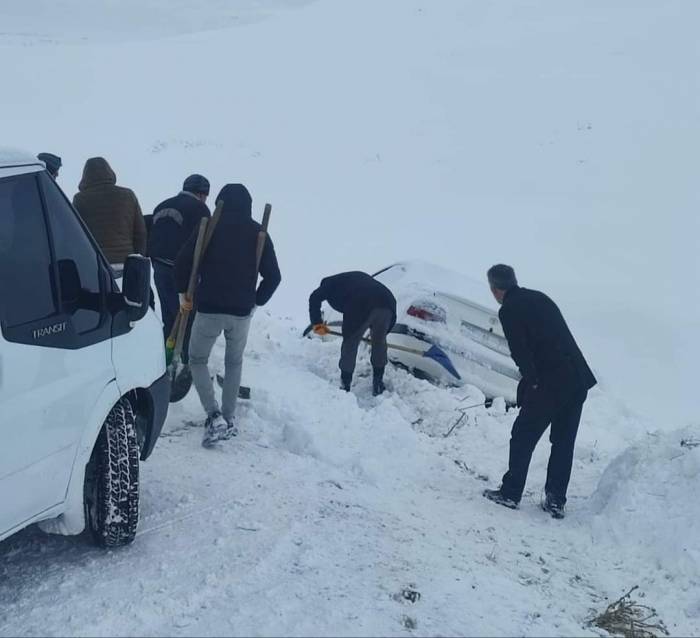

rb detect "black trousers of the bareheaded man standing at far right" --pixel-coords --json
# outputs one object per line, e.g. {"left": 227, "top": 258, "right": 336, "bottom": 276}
{"left": 501, "top": 389, "right": 588, "bottom": 504}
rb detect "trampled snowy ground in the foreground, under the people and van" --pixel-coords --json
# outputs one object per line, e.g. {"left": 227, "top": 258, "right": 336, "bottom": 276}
{"left": 0, "top": 312, "right": 700, "bottom": 636}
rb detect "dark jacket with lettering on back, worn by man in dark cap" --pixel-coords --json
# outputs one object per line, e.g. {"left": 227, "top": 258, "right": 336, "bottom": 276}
{"left": 148, "top": 191, "right": 209, "bottom": 264}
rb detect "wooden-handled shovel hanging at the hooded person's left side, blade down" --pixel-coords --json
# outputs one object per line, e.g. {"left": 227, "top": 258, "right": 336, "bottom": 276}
{"left": 165, "top": 201, "right": 223, "bottom": 403}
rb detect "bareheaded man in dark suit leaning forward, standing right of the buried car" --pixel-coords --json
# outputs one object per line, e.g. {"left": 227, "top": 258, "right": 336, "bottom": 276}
{"left": 484, "top": 264, "right": 596, "bottom": 518}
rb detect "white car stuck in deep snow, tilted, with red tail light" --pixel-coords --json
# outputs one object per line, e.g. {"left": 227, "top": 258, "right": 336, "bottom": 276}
{"left": 312, "top": 261, "right": 520, "bottom": 404}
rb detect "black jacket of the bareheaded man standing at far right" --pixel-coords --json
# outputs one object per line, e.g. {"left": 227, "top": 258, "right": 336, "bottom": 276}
{"left": 498, "top": 286, "right": 596, "bottom": 394}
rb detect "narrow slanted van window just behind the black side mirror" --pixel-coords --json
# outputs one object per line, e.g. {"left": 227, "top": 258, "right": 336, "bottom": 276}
{"left": 39, "top": 172, "right": 104, "bottom": 335}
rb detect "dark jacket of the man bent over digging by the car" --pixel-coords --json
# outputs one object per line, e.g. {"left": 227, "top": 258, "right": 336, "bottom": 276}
{"left": 309, "top": 271, "right": 396, "bottom": 335}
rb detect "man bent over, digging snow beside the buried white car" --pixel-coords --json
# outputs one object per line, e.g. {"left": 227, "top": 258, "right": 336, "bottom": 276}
{"left": 309, "top": 271, "right": 396, "bottom": 396}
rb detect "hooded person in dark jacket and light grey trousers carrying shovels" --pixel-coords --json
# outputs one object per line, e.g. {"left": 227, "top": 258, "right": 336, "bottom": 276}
{"left": 175, "top": 184, "right": 282, "bottom": 447}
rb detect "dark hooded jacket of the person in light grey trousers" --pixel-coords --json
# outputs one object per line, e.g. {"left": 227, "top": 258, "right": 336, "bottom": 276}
{"left": 175, "top": 184, "right": 282, "bottom": 317}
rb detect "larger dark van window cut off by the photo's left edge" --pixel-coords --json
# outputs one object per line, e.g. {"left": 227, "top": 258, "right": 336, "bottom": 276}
{"left": 0, "top": 174, "right": 58, "bottom": 328}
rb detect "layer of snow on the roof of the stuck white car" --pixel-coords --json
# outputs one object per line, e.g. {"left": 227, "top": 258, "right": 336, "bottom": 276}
{"left": 377, "top": 260, "right": 497, "bottom": 309}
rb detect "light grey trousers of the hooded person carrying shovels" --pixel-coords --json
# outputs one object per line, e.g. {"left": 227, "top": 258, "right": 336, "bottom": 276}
{"left": 190, "top": 312, "right": 252, "bottom": 420}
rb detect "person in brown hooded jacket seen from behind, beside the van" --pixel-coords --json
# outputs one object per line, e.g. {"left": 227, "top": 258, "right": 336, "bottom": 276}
{"left": 73, "top": 157, "right": 146, "bottom": 264}
